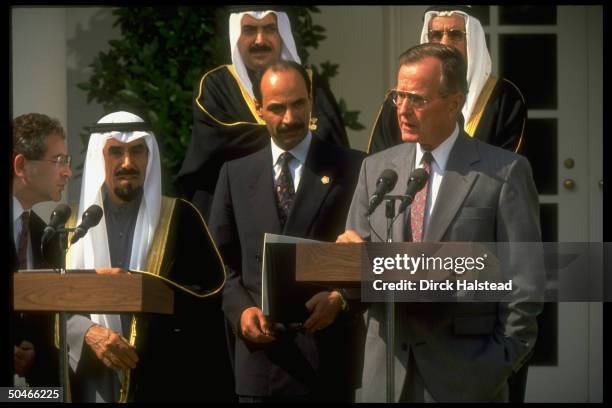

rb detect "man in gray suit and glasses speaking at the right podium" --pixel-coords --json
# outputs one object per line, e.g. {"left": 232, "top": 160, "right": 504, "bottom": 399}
{"left": 338, "top": 44, "right": 541, "bottom": 402}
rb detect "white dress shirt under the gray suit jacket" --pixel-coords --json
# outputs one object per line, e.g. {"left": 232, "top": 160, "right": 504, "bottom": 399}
{"left": 414, "top": 124, "right": 459, "bottom": 233}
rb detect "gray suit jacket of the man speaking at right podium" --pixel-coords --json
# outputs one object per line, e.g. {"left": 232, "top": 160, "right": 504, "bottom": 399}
{"left": 346, "top": 132, "right": 541, "bottom": 401}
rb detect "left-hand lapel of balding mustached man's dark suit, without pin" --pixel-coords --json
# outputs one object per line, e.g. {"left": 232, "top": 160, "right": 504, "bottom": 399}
{"left": 247, "top": 148, "right": 281, "bottom": 234}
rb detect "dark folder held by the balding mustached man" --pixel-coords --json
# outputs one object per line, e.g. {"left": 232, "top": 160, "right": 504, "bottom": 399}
{"left": 261, "top": 234, "right": 325, "bottom": 325}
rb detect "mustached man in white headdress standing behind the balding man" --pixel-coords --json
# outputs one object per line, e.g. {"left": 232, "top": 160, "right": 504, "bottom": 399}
{"left": 177, "top": 7, "right": 349, "bottom": 220}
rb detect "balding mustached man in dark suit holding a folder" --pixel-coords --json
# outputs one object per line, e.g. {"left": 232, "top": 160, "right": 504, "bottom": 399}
{"left": 210, "top": 61, "right": 364, "bottom": 402}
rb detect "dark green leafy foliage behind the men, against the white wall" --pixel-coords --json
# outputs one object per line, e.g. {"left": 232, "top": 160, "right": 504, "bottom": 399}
{"left": 79, "top": 6, "right": 363, "bottom": 193}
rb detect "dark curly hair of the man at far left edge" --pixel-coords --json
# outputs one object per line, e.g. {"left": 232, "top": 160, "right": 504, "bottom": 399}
{"left": 12, "top": 113, "right": 66, "bottom": 160}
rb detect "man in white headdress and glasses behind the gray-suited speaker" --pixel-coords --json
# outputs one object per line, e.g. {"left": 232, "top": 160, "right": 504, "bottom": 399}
{"left": 368, "top": 5, "right": 527, "bottom": 153}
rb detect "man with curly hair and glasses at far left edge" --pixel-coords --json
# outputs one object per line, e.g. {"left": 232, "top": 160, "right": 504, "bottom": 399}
{"left": 12, "top": 113, "right": 72, "bottom": 386}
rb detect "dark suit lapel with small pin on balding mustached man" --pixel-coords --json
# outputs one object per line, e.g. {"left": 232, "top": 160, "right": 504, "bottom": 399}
{"left": 283, "top": 136, "right": 336, "bottom": 236}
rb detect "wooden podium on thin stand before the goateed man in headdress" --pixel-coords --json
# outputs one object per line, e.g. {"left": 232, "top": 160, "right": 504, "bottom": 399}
{"left": 13, "top": 270, "right": 174, "bottom": 401}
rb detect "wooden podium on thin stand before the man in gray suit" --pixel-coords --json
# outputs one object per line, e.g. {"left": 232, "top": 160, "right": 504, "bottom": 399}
{"left": 262, "top": 238, "right": 512, "bottom": 402}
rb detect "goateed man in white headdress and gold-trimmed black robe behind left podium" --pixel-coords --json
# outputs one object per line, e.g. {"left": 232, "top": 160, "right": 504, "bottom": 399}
{"left": 67, "top": 112, "right": 232, "bottom": 402}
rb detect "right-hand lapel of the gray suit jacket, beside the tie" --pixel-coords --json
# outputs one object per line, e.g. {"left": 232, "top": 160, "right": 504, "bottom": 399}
{"left": 424, "top": 132, "right": 480, "bottom": 241}
